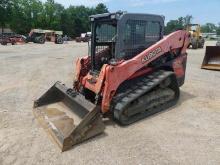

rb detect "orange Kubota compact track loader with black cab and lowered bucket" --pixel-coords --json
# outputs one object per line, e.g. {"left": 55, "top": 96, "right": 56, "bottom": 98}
{"left": 33, "top": 12, "right": 190, "bottom": 151}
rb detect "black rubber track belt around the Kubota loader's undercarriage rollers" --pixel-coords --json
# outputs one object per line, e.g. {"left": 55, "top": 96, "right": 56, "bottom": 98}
{"left": 113, "top": 70, "right": 179, "bottom": 125}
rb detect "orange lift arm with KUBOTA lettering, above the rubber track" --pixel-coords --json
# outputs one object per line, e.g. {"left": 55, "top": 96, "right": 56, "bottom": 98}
{"left": 102, "top": 30, "right": 189, "bottom": 112}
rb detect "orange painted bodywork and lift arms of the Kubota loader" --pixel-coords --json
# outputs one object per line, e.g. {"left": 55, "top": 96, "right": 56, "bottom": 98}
{"left": 74, "top": 30, "right": 189, "bottom": 113}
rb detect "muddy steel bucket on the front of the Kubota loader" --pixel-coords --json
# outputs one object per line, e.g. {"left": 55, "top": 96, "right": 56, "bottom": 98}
{"left": 33, "top": 83, "right": 105, "bottom": 151}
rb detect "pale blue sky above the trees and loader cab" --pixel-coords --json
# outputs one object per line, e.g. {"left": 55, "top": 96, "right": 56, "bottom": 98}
{"left": 43, "top": 0, "right": 220, "bottom": 24}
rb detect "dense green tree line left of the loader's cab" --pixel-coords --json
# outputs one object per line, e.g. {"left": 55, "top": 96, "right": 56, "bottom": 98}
{"left": 0, "top": 0, "right": 108, "bottom": 37}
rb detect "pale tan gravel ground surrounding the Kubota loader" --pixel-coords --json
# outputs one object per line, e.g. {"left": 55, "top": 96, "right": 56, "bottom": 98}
{"left": 0, "top": 42, "right": 220, "bottom": 165}
